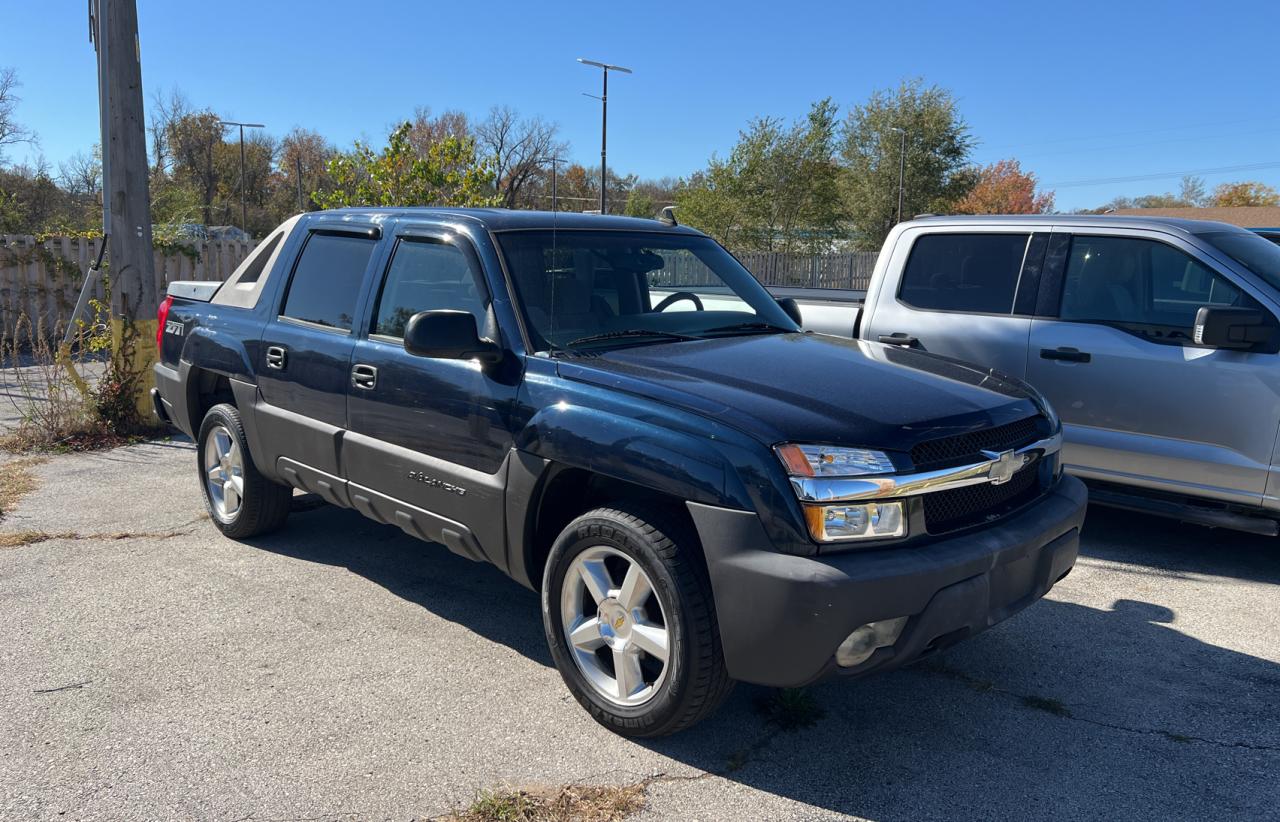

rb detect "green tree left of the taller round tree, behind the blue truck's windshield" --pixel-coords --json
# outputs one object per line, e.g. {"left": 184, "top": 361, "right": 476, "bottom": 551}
{"left": 676, "top": 99, "right": 842, "bottom": 251}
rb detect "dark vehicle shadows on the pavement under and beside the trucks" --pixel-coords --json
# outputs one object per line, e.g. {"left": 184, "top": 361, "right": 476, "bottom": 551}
{"left": 244, "top": 507, "right": 1280, "bottom": 819}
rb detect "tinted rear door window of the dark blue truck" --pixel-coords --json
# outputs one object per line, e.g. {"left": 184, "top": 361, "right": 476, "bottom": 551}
{"left": 280, "top": 234, "right": 378, "bottom": 332}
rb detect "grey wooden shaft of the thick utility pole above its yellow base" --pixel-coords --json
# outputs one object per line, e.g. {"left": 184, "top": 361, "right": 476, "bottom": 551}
{"left": 91, "top": 0, "right": 160, "bottom": 320}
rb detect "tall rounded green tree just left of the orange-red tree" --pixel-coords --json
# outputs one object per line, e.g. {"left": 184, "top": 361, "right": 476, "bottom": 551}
{"left": 840, "top": 79, "right": 977, "bottom": 250}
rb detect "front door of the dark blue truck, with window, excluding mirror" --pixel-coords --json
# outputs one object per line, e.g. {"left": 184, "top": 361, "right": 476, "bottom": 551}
{"left": 343, "top": 228, "right": 520, "bottom": 567}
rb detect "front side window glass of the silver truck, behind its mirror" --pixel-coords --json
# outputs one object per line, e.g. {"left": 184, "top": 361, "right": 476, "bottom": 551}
{"left": 1059, "top": 236, "right": 1257, "bottom": 344}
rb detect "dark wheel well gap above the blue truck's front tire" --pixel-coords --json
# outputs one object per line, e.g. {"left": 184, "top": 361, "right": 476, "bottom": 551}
{"left": 525, "top": 469, "right": 698, "bottom": 590}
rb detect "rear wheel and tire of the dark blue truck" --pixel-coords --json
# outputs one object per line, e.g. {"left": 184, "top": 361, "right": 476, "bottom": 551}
{"left": 196, "top": 403, "right": 293, "bottom": 539}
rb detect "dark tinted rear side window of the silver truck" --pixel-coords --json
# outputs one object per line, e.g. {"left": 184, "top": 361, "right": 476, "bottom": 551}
{"left": 899, "top": 233, "right": 1029, "bottom": 314}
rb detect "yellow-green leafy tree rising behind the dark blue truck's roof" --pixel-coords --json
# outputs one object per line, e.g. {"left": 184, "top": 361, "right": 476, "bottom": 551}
{"left": 312, "top": 122, "right": 494, "bottom": 209}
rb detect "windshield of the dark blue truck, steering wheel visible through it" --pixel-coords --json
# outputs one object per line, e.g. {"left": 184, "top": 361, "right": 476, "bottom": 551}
{"left": 497, "top": 230, "right": 800, "bottom": 351}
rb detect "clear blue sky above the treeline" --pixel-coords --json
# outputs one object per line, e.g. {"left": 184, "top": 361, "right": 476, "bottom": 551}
{"left": 0, "top": 0, "right": 1280, "bottom": 209}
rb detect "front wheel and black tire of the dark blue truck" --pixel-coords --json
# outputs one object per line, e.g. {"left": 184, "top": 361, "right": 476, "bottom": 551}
{"left": 541, "top": 506, "right": 733, "bottom": 737}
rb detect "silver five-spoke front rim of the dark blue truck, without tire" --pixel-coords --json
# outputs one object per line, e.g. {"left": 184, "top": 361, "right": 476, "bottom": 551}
{"left": 561, "top": 545, "right": 671, "bottom": 707}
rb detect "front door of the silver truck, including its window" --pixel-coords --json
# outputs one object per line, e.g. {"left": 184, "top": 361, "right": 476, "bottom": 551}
{"left": 1027, "top": 228, "right": 1280, "bottom": 504}
